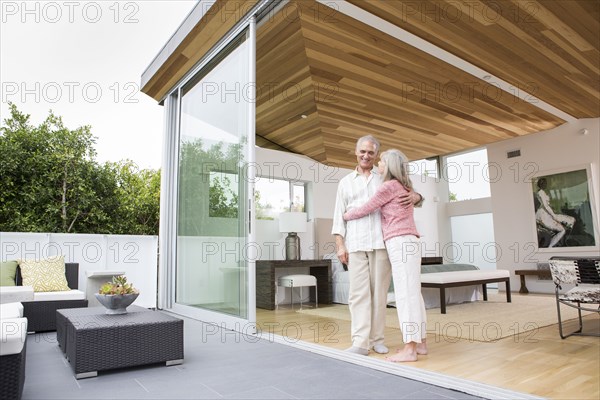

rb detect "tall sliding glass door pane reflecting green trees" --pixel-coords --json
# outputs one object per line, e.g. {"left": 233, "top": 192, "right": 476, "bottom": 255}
{"left": 175, "top": 35, "right": 250, "bottom": 318}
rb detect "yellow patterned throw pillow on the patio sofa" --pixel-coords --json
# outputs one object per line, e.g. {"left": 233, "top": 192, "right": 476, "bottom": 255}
{"left": 19, "top": 256, "right": 71, "bottom": 292}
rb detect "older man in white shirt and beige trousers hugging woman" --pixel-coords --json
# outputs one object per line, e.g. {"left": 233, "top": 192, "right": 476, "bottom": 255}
{"left": 331, "top": 135, "right": 423, "bottom": 355}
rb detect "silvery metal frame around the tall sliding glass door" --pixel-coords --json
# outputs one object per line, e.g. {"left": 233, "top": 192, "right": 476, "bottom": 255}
{"left": 158, "top": 0, "right": 270, "bottom": 334}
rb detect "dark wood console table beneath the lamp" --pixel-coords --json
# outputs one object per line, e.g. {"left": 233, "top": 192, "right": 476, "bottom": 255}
{"left": 256, "top": 260, "right": 333, "bottom": 310}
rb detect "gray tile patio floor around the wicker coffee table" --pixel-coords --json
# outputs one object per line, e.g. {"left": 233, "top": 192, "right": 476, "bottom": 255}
{"left": 23, "top": 312, "right": 500, "bottom": 399}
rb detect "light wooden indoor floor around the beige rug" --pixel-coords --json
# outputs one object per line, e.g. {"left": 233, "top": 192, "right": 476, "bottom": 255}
{"left": 257, "top": 293, "right": 600, "bottom": 399}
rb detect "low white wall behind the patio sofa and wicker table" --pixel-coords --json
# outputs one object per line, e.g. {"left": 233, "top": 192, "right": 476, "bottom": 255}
{"left": 0, "top": 232, "right": 158, "bottom": 308}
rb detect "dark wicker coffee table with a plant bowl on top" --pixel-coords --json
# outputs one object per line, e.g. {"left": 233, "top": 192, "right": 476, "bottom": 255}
{"left": 56, "top": 306, "right": 183, "bottom": 379}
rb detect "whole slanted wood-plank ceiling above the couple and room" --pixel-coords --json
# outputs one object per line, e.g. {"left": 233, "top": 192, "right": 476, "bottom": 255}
{"left": 256, "top": 0, "right": 600, "bottom": 168}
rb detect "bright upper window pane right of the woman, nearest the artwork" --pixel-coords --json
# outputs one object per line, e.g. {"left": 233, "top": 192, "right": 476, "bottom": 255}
{"left": 443, "top": 149, "right": 491, "bottom": 201}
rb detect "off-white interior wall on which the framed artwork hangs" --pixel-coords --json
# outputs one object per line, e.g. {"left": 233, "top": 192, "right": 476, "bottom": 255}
{"left": 487, "top": 118, "right": 600, "bottom": 293}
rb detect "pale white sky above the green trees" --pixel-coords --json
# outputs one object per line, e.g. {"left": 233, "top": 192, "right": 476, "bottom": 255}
{"left": 0, "top": 0, "right": 197, "bottom": 169}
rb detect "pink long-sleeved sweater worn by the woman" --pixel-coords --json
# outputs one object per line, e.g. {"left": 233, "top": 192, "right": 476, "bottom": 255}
{"left": 344, "top": 179, "right": 419, "bottom": 240}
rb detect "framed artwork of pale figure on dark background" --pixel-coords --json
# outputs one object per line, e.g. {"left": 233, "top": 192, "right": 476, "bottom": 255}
{"left": 531, "top": 165, "right": 598, "bottom": 251}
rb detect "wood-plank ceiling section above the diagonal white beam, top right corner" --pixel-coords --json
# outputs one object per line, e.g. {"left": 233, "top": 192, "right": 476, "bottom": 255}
{"left": 349, "top": 0, "right": 600, "bottom": 118}
